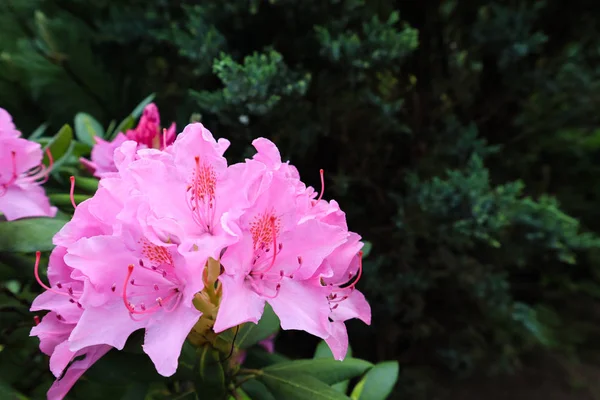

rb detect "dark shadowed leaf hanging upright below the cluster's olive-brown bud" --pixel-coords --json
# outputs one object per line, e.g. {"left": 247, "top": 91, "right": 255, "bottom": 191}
{"left": 194, "top": 346, "right": 227, "bottom": 400}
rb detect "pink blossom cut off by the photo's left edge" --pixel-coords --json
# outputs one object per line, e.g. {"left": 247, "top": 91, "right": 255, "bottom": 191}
{"left": 0, "top": 108, "right": 56, "bottom": 221}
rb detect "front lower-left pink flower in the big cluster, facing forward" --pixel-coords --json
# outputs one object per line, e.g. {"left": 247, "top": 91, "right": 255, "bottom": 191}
{"left": 65, "top": 228, "right": 206, "bottom": 376}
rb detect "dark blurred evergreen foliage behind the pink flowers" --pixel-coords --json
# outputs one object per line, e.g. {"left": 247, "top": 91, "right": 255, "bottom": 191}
{"left": 0, "top": 0, "right": 600, "bottom": 400}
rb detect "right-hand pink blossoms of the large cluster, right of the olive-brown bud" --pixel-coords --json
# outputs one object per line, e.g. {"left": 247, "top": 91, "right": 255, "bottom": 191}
{"left": 214, "top": 138, "right": 371, "bottom": 359}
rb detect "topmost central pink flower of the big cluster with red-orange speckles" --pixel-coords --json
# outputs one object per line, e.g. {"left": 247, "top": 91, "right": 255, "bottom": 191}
{"left": 115, "top": 123, "right": 252, "bottom": 259}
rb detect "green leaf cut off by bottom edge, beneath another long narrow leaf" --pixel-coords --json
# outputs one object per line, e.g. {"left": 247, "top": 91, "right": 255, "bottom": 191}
{"left": 258, "top": 371, "right": 348, "bottom": 400}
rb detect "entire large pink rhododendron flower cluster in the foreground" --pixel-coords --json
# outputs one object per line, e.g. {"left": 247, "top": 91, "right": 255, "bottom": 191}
{"left": 32, "top": 123, "right": 371, "bottom": 398}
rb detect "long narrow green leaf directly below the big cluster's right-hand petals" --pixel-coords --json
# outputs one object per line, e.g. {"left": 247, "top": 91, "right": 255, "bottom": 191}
{"left": 264, "top": 358, "right": 373, "bottom": 385}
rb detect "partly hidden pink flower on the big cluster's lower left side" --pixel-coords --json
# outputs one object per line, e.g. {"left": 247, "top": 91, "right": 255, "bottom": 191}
{"left": 31, "top": 247, "right": 111, "bottom": 400}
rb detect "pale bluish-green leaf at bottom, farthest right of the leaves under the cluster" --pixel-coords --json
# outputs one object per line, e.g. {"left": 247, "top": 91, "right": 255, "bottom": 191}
{"left": 350, "top": 361, "right": 398, "bottom": 400}
